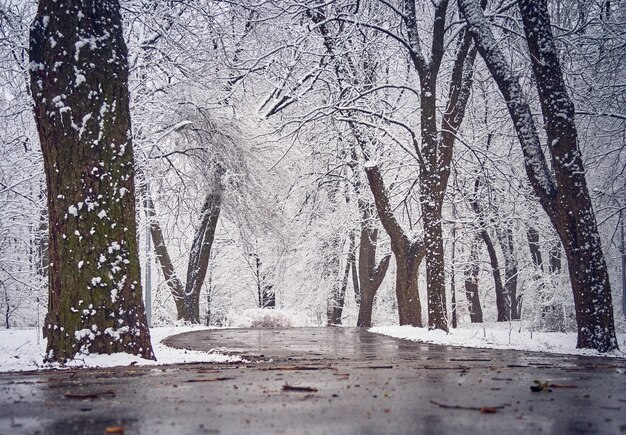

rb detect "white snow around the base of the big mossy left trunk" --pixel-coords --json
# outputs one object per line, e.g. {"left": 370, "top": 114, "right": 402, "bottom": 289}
{"left": 0, "top": 326, "right": 241, "bottom": 372}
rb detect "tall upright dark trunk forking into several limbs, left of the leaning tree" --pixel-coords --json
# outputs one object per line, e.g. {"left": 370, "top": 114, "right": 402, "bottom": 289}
{"left": 403, "top": 0, "right": 476, "bottom": 331}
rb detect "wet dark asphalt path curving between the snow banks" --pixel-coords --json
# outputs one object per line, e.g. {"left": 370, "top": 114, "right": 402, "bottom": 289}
{"left": 0, "top": 328, "right": 626, "bottom": 435}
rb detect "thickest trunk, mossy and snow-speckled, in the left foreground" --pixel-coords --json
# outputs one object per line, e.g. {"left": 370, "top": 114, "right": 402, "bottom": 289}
{"left": 30, "top": 0, "right": 154, "bottom": 362}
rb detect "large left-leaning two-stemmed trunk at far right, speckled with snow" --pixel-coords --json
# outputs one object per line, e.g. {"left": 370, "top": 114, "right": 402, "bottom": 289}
{"left": 459, "top": 0, "right": 618, "bottom": 352}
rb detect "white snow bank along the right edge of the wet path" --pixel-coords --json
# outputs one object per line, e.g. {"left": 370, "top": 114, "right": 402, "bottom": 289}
{"left": 370, "top": 322, "right": 626, "bottom": 358}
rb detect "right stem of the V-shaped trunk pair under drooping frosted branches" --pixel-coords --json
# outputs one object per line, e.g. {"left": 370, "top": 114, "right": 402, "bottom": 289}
{"left": 183, "top": 183, "right": 223, "bottom": 323}
